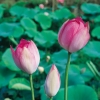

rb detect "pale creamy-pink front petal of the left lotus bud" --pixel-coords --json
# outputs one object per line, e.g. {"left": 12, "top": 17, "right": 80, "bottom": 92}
{"left": 19, "top": 47, "right": 37, "bottom": 74}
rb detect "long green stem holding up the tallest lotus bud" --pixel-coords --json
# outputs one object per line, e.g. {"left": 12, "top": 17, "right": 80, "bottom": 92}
{"left": 64, "top": 52, "right": 71, "bottom": 100}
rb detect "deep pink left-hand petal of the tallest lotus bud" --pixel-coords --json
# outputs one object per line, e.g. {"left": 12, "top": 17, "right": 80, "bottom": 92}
{"left": 58, "top": 20, "right": 79, "bottom": 50}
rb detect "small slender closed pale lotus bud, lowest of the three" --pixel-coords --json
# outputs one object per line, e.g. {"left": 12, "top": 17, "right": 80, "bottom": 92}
{"left": 45, "top": 65, "right": 60, "bottom": 97}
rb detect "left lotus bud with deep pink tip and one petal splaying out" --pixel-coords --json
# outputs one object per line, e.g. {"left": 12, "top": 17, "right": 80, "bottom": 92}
{"left": 10, "top": 39, "right": 40, "bottom": 74}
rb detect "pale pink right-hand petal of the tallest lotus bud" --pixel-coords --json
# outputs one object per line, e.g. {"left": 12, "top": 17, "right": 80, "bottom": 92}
{"left": 69, "top": 27, "right": 90, "bottom": 52}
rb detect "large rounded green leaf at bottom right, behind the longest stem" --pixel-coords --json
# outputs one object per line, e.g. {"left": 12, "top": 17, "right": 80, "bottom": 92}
{"left": 55, "top": 85, "right": 98, "bottom": 100}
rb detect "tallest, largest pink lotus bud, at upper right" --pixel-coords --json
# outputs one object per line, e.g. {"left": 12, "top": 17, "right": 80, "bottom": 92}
{"left": 58, "top": 17, "right": 90, "bottom": 52}
